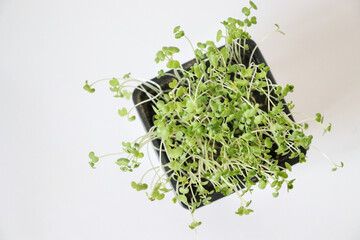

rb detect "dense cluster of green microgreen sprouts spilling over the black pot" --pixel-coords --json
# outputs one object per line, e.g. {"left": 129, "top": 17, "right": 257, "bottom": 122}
{"left": 84, "top": 1, "right": 343, "bottom": 232}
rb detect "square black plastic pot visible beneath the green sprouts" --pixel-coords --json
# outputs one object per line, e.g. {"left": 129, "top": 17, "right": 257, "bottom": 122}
{"left": 133, "top": 39, "right": 306, "bottom": 209}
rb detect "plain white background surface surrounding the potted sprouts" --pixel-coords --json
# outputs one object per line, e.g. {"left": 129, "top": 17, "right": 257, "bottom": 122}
{"left": 0, "top": 0, "right": 360, "bottom": 240}
